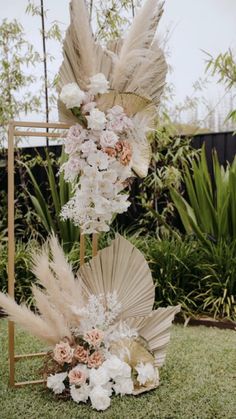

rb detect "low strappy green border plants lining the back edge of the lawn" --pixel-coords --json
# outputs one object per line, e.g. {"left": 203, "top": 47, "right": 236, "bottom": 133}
{"left": 0, "top": 232, "right": 236, "bottom": 320}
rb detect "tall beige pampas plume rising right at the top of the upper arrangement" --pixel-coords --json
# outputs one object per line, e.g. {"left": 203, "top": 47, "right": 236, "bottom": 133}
{"left": 112, "top": 0, "right": 166, "bottom": 92}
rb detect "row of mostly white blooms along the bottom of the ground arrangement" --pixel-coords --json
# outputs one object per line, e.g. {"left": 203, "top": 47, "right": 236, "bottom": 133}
{"left": 47, "top": 355, "right": 156, "bottom": 410}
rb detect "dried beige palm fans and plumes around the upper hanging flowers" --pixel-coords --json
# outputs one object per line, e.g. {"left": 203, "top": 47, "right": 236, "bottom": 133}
{"left": 58, "top": 0, "right": 167, "bottom": 177}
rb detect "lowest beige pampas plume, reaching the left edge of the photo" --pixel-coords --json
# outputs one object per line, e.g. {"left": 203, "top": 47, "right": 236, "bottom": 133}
{"left": 0, "top": 293, "right": 60, "bottom": 344}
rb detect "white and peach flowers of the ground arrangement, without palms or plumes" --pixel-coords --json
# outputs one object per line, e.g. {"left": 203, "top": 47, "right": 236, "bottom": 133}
{"left": 45, "top": 292, "right": 159, "bottom": 410}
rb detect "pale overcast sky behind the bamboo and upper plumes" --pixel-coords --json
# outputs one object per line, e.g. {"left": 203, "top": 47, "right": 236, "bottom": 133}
{"left": 0, "top": 0, "right": 236, "bottom": 144}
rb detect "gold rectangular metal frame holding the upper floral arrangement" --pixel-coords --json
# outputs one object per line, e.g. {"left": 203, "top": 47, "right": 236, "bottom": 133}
{"left": 8, "top": 121, "right": 98, "bottom": 387}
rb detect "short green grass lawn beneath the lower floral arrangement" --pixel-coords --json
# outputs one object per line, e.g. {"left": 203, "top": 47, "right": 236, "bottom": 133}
{"left": 0, "top": 320, "right": 236, "bottom": 419}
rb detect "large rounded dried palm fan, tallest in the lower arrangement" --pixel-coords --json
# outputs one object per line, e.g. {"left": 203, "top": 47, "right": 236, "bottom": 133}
{"left": 79, "top": 235, "right": 155, "bottom": 319}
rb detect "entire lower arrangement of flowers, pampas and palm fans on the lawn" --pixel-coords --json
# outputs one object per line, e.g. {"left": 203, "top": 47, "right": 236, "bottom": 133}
{"left": 0, "top": 235, "right": 180, "bottom": 410}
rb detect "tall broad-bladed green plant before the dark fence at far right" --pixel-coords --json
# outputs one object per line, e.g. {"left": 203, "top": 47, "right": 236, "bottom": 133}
{"left": 171, "top": 148, "right": 236, "bottom": 245}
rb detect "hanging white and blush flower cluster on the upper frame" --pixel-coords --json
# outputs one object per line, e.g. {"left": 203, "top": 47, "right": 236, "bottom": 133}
{"left": 60, "top": 74, "right": 133, "bottom": 234}
